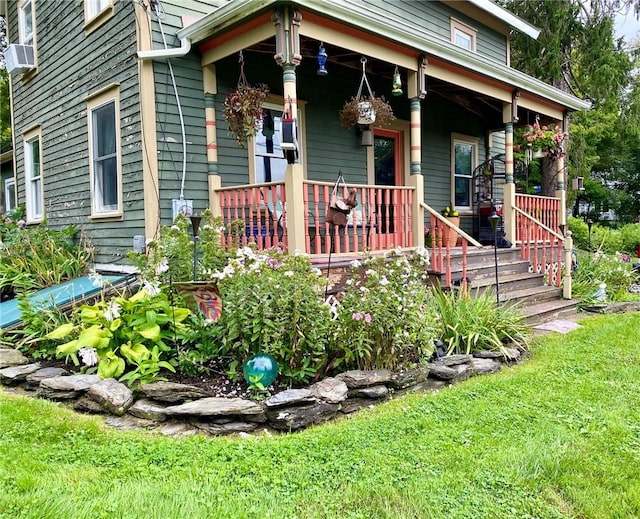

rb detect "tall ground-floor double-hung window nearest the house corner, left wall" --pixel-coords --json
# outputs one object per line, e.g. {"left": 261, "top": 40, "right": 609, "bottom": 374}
{"left": 87, "top": 89, "right": 122, "bottom": 218}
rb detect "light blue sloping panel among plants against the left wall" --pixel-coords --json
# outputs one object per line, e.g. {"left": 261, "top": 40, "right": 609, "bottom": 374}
{"left": 0, "top": 275, "right": 129, "bottom": 329}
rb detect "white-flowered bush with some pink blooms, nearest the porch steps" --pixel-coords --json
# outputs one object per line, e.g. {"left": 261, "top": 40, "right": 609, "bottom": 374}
{"left": 331, "top": 248, "right": 436, "bottom": 371}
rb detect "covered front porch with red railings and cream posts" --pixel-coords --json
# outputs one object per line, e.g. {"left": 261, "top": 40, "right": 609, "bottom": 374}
{"left": 171, "top": 1, "right": 584, "bottom": 294}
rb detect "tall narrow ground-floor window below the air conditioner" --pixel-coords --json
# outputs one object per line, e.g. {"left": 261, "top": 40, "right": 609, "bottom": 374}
{"left": 23, "top": 126, "right": 44, "bottom": 223}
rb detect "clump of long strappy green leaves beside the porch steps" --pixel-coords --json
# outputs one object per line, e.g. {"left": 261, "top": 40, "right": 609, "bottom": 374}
{"left": 433, "top": 289, "right": 528, "bottom": 355}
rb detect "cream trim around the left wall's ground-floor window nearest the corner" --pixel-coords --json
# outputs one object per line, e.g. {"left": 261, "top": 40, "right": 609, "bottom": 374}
{"left": 87, "top": 86, "right": 123, "bottom": 219}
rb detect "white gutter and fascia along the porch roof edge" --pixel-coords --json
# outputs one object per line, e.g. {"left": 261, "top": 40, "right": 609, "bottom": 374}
{"left": 177, "top": 0, "right": 591, "bottom": 110}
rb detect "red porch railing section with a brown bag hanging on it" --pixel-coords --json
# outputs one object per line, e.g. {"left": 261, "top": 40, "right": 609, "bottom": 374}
{"left": 303, "top": 180, "right": 414, "bottom": 254}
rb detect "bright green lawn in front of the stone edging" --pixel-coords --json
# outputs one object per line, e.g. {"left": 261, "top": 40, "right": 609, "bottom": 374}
{"left": 0, "top": 314, "right": 640, "bottom": 519}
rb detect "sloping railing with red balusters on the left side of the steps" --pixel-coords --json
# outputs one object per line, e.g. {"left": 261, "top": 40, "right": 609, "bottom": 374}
{"left": 421, "top": 203, "right": 482, "bottom": 287}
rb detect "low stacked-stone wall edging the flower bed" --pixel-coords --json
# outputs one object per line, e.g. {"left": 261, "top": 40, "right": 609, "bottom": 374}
{"left": 0, "top": 347, "right": 520, "bottom": 436}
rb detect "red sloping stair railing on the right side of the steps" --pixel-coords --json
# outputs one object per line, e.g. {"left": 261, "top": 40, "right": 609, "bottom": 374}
{"left": 513, "top": 207, "right": 564, "bottom": 287}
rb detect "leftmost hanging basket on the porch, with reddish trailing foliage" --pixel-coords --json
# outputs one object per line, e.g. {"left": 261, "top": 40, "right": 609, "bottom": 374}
{"left": 224, "top": 52, "right": 269, "bottom": 148}
